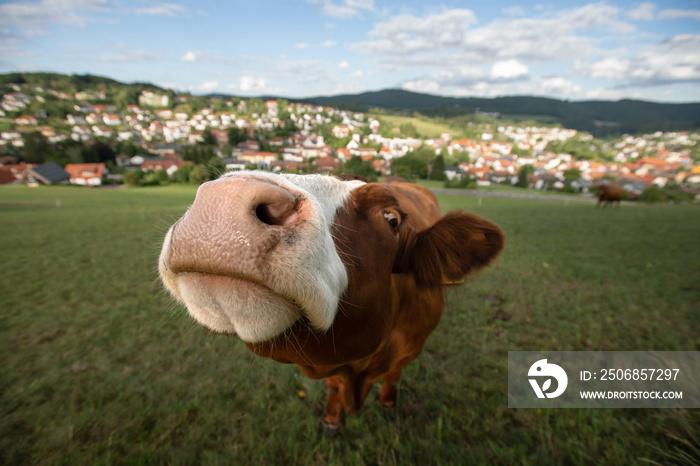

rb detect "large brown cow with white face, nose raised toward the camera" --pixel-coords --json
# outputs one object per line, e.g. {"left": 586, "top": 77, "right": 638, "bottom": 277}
{"left": 159, "top": 171, "right": 504, "bottom": 432}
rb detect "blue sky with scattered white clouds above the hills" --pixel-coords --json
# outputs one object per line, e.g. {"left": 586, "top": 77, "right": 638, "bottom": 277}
{"left": 0, "top": 0, "right": 700, "bottom": 102}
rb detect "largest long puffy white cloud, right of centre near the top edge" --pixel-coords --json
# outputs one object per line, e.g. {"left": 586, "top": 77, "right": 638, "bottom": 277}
{"left": 351, "top": 3, "right": 635, "bottom": 63}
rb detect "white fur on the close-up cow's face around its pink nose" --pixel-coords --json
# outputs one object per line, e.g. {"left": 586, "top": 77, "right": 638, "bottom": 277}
{"left": 159, "top": 172, "right": 364, "bottom": 342}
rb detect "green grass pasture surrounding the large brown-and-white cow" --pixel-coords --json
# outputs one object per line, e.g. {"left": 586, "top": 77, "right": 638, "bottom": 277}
{"left": 0, "top": 186, "right": 700, "bottom": 466}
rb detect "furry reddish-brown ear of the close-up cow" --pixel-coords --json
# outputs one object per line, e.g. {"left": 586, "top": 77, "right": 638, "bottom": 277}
{"left": 394, "top": 212, "right": 505, "bottom": 286}
